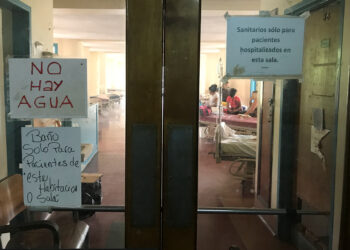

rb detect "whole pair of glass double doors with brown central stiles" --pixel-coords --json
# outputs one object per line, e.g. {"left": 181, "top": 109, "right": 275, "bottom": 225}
{"left": 0, "top": 0, "right": 341, "bottom": 250}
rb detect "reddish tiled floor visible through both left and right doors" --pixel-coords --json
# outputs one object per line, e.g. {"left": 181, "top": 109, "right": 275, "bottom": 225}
{"left": 80, "top": 98, "right": 294, "bottom": 250}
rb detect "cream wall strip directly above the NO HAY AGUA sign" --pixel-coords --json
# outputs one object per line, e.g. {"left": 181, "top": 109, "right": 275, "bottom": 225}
{"left": 22, "top": 0, "right": 53, "bottom": 57}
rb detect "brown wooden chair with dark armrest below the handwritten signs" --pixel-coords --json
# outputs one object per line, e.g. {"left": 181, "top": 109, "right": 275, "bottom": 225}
{"left": 0, "top": 174, "right": 89, "bottom": 249}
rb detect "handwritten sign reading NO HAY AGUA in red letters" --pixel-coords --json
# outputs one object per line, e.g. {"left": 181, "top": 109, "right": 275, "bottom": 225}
{"left": 9, "top": 58, "right": 88, "bottom": 118}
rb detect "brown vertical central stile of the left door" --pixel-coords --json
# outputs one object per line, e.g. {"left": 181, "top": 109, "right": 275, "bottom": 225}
{"left": 125, "top": 0, "right": 164, "bottom": 249}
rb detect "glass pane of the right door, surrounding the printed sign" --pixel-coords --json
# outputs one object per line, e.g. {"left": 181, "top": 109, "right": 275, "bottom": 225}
{"left": 197, "top": 0, "right": 343, "bottom": 249}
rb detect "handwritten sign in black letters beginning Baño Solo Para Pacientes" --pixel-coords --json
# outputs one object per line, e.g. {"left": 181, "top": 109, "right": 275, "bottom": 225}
{"left": 22, "top": 127, "right": 81, "bottom": 207}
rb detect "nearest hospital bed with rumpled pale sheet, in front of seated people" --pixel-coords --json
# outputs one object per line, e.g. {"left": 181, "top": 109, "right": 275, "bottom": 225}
{"left": 215, "top": 122, "right": 256, "bottom": 192}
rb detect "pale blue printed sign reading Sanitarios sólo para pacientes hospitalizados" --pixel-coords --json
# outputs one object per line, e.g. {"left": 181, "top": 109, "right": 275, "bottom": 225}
{"left": 226, "top": 16, "right": 305, "bottom": 78}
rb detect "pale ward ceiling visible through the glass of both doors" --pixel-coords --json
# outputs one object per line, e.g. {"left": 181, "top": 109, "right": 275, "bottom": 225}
{"left": 54, "top": 6, "right": 258, "bottom": 53}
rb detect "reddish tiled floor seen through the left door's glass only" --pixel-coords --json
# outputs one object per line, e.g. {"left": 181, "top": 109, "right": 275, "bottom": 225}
{"left": 84, "top": 102, "right": 125, "bottom": 248}
